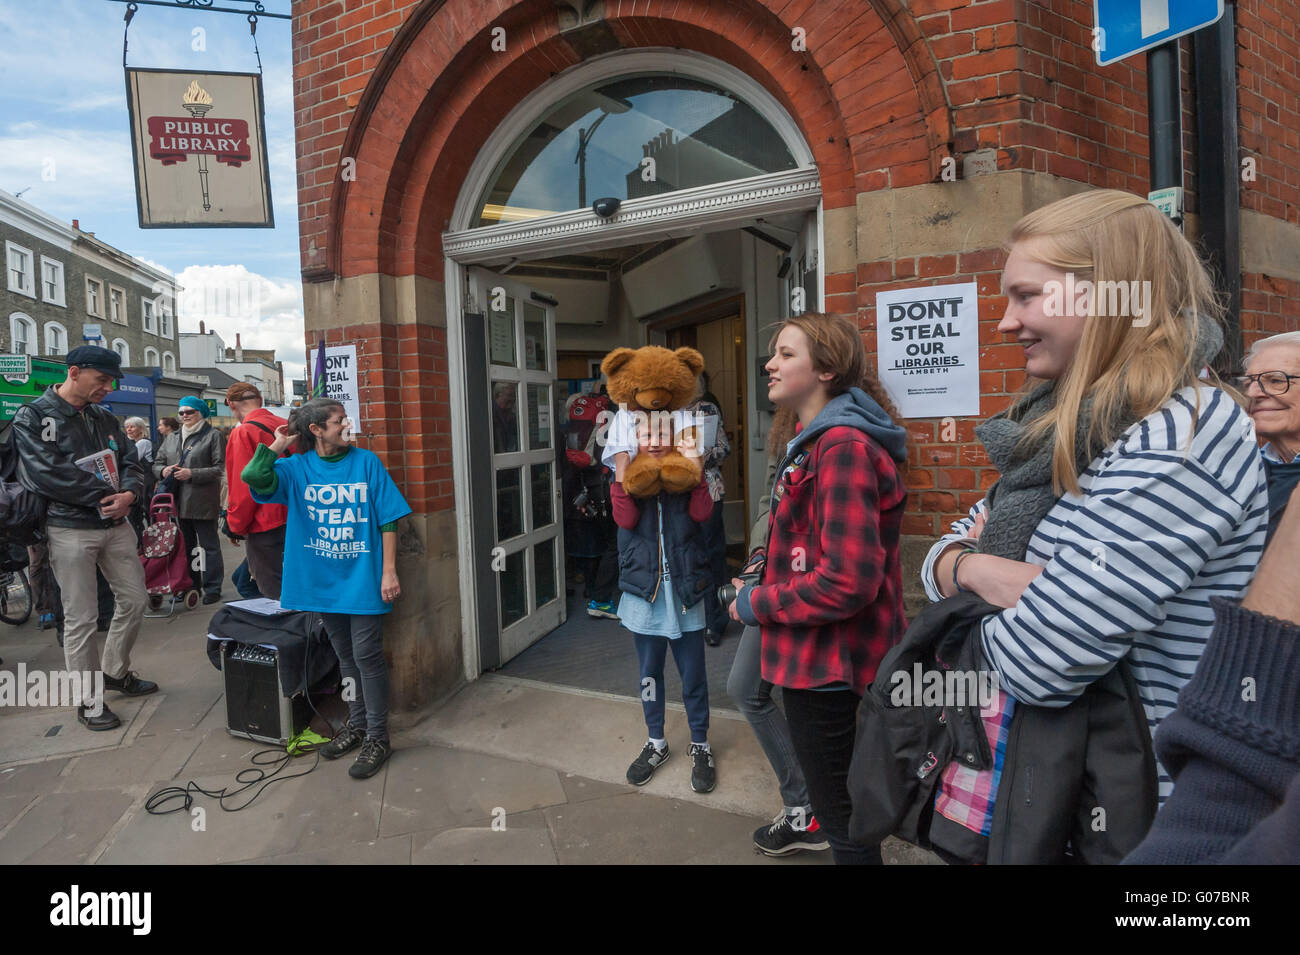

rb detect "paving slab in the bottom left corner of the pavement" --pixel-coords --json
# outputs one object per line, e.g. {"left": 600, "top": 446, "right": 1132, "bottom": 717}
{"left": 0, "top": 789, "right": 135, "bottom": 865}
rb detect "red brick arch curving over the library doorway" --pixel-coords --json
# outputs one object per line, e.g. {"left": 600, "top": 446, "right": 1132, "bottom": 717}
{"left": 302, "top": 0, "right": 952, "bottom": 283}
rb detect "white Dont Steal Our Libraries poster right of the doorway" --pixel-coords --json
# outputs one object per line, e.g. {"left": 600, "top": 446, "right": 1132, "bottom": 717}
{"left": 876, "top": 282, "right": 979, "bottom": 418}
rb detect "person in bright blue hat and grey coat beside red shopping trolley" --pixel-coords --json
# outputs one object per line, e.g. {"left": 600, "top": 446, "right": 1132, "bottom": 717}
{"left": 153, "top": 395, "right": 226, "bottom": 603}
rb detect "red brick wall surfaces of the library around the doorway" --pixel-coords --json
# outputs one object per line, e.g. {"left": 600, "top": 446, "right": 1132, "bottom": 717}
{"left": 294, "top": 0, "right": 1300, "bottom": 522}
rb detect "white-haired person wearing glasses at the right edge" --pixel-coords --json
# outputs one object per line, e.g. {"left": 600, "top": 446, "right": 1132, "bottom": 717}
{"left": 1238, "top": 331, "right": 1300, "bottom": 538}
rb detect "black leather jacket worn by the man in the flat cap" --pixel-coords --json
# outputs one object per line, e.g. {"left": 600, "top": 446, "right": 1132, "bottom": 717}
{"left": 13, "top": 385, "right": 144, "bottom": 528}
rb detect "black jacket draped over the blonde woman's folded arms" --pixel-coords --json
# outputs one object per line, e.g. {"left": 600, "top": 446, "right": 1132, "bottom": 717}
{"left": 849, "top": 594, "right": 1157, "bottom": 864}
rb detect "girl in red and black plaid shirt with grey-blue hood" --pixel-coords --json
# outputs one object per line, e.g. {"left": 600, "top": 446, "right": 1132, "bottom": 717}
{"left": 729, "top": 314, "right": 906, "bottom": 864}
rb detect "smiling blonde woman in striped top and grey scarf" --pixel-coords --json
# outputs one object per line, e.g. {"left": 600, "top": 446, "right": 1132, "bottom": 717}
{"left": 922, "top": 191, "right": 1268, "bottom": 861}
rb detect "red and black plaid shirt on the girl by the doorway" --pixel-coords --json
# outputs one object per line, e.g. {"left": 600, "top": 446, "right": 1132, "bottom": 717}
{"left": 749, "top": 426, "right": 907, "bottom": 695}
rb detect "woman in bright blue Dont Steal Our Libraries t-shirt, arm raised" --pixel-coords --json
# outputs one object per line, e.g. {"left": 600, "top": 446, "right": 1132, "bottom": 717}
{"left": 241, "top": 398, "right": 411, "bottom": 780}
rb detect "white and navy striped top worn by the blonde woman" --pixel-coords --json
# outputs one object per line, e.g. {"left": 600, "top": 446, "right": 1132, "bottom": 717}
{"left": 922, "top": 386, "right": 1268, "bottom": 800}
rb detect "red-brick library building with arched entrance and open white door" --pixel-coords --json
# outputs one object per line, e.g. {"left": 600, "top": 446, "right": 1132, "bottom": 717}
{"left": 294, "top": 0, "right": 1300, "bottom": 706}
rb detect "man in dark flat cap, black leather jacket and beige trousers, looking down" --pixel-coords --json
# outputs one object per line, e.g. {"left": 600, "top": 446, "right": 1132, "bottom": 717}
{"left": 13, "top": 344, "right": 159, "bottom": 730}
